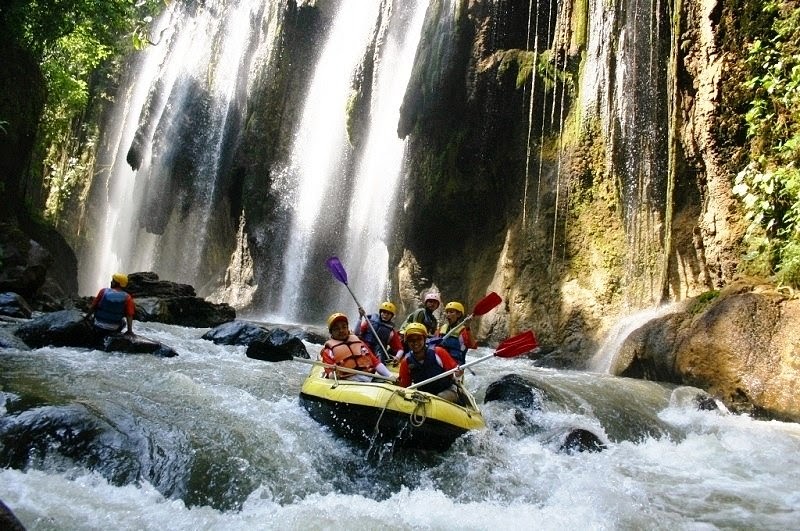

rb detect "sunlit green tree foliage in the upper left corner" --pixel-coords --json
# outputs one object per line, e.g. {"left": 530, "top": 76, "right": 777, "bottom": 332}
{"left": 0, "top": 0, "right": 164, "bottom": 218}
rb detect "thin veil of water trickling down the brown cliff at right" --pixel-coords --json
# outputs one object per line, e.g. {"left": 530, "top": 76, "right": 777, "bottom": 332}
{"left": 579, "top": 0, "right": 669, "bottom": 303}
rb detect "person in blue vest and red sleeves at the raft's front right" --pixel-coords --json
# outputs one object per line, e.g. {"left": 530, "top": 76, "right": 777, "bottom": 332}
{"left": 397, "top": 323, "right": 461, "bottom": 403}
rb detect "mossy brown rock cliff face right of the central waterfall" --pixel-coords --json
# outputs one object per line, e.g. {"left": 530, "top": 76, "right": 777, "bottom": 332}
{"left": 391, "top": 0, "right": 742, "bottom": 360}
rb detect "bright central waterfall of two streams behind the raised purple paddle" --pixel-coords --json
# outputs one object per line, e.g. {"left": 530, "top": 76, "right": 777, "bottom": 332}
{"left": 274, "top": 0, "right": 427, "bottom": 321}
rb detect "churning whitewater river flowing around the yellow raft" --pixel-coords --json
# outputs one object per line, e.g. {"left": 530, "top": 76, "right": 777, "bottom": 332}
{"left": 0, "top": 323, "right": 800, "bottom": 530}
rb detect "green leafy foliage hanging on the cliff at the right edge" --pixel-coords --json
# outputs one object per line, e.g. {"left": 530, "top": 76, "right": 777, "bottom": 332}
{"left": 733, "top": 0, "right": 800, "bottom": 287}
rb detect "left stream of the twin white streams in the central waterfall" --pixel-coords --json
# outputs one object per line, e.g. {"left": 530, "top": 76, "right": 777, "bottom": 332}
{"left": 270, "top": 1, "right": 379, "bottom": 321}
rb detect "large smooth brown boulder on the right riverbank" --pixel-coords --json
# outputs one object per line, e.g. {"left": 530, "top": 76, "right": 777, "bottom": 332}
{"left": 611, "top": 279, "right": 800, "bottom": 422}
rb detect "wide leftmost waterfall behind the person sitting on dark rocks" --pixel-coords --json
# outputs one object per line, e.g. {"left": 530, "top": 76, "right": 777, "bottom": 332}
{"left": 79, "top": 0, "right": 280, "bottom": 292}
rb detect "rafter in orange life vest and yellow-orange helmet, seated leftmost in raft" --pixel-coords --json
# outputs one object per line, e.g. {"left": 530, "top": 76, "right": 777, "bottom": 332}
{"left": 320, "top": 313, "right": 394, "bottom": 382}
